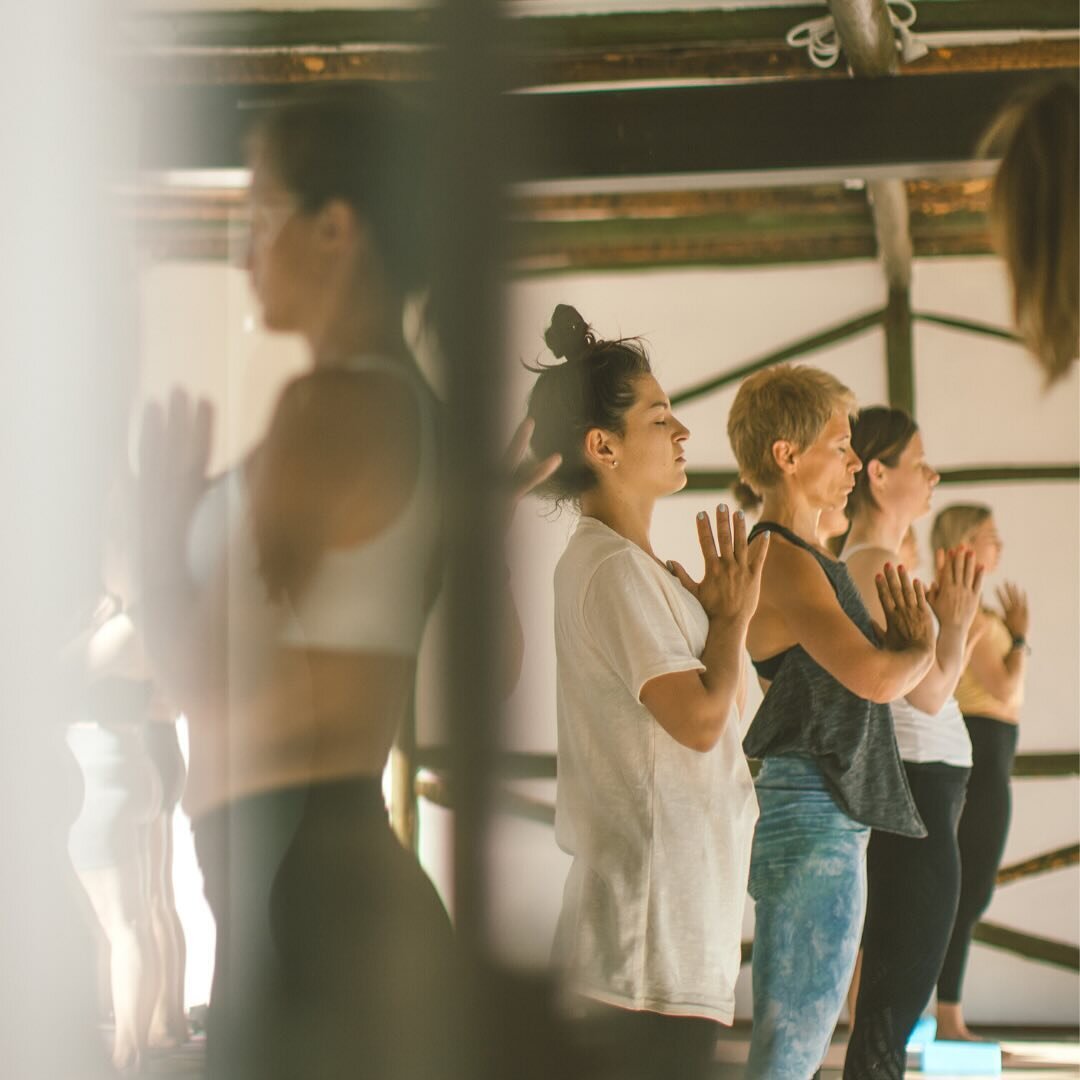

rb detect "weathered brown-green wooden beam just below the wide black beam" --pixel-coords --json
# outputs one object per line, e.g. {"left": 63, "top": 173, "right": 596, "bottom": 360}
{"left": 128, "top": 179, "right": 990, "bottom": 268}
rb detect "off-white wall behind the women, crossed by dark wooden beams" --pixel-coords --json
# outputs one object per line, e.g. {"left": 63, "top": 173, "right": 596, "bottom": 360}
{"left": 143, "top": 250, "right": 1080, "bottom": 1024}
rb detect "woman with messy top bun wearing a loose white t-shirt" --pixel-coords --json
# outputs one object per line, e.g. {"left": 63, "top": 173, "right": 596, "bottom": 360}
{"left": 528, "top": 306, "right": 768, "bottom": 1080}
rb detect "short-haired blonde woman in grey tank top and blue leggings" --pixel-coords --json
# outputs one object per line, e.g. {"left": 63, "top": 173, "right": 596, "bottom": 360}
{"left": 728, "top": 365, "right": 934, "bottom": 1080}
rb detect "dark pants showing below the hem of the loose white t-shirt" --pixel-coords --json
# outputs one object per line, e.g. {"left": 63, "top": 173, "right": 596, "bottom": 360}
{"left": 586, "top": 1005, "right": 719, "bottom": 1080}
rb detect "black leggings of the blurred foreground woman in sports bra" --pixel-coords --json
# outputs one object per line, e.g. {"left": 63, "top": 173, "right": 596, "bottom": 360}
{"left": 195, "top": 780, "right": 454, "bottom": 1080}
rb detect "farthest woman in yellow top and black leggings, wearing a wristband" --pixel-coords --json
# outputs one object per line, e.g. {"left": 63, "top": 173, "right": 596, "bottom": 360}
{"left": 931, "top": 503, "right": 1030, "bottom": 1040}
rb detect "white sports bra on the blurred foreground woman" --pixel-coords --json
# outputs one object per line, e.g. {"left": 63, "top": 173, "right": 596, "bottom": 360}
{"left": 188, "top": 356, "right": 441, "bottom": 656}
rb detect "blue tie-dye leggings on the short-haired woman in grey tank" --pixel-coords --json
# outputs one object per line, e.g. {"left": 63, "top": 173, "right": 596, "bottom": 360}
{"left": 746, "top": 757, "right": 870, "bottom": 1080}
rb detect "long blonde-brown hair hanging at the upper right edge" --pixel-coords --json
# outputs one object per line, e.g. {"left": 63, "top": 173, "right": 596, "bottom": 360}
{"left": 981, "top": 83, "right": 1080, "bottom": 382}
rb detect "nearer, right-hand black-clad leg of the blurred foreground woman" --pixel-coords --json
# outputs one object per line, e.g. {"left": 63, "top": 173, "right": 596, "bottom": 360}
{"left": 272, "top": 781, "right": 460, "bottom": 1080}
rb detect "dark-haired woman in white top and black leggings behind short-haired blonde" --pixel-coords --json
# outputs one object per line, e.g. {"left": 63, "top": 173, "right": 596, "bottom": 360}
{"left": 843, "top": 407, "right": 983, "bottom": 1080}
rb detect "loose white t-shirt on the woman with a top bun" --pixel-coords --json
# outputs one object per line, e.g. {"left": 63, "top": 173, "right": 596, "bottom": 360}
{"left": 554, "top": 517, "right": 757, "bottom": 1024}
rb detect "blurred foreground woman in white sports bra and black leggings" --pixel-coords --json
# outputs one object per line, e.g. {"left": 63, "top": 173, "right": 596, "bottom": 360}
{"left": 140, "top": 94, "right": 453, "bottom": 1080}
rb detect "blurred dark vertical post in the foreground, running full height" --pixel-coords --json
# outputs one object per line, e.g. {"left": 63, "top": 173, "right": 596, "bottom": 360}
{"left": 431, "top": 0, "right": 505, "bottom": 1080}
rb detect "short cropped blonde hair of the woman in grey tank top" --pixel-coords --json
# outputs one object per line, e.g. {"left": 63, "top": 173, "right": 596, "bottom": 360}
{"left": 728, "top": 364, "right": 855, "bottom": 492}
